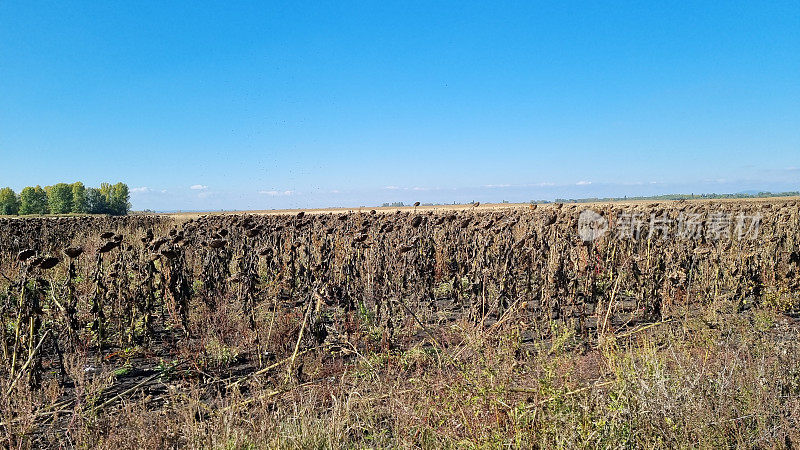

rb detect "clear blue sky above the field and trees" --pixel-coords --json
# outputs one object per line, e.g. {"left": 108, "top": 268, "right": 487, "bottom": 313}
{"left": 0, "top": 0, "right": 800, "bottom": 210}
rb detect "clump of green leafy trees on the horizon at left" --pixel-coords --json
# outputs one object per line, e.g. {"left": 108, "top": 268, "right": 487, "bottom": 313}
{"left": 0, "top": 181, "right": 131, "bottom": 216}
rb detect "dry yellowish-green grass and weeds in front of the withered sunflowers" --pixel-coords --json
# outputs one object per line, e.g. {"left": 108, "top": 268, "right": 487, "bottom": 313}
{"left": 6, "top": 304, "right": 800, "bottom": 449}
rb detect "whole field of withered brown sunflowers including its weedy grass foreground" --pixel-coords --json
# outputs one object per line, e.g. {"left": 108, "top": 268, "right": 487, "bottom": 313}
{"left": 0, "top": 199, "right": 800, "bottom": 448}
